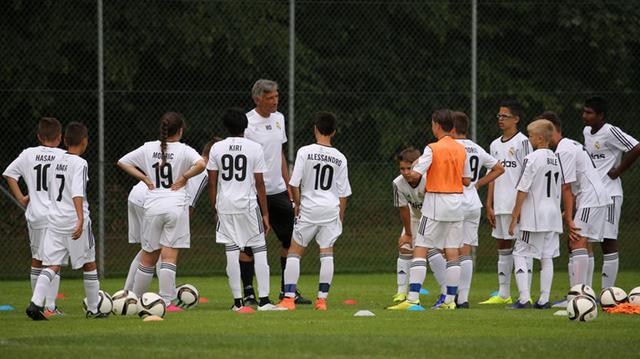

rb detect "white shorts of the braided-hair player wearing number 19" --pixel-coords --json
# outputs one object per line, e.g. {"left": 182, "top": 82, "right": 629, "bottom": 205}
{"left": 142, "top": 205, "right": 191, "bottom": 252}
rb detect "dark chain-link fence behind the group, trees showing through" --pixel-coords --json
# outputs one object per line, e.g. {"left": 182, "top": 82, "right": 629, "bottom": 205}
{"left": 0, "top": 0, "right": 640, "bottom": 278}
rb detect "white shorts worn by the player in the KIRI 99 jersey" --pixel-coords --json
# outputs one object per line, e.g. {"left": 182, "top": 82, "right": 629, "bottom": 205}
{"left": 216, "top": 207, "right": 266, "bottom": 249}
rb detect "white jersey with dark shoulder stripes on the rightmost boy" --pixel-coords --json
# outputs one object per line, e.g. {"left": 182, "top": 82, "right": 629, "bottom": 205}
{"left": 583, "top": 123, "right": 638, "bottom": 196}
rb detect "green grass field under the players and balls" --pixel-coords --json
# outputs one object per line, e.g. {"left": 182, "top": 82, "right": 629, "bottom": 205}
{"left": 0, "top": 272, "right": 640, "bottom": 358}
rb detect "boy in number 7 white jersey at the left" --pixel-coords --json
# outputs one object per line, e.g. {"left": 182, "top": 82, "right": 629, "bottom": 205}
{"left": 27, "top": 122, "right": 108, "bottom": 320}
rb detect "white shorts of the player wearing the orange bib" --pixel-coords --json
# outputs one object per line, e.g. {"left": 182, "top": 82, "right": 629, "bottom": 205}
{"left": 414, "top": 216, "right": 464, "bottom": 249}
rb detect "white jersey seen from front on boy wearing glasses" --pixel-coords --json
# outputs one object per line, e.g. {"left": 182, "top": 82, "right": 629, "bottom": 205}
{"left": 489, "top": 132, "right": 533, "bottom": 214}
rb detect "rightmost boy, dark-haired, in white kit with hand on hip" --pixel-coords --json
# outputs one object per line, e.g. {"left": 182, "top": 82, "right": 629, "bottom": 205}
{"left": 582, "top": 97, "right": 640, "bottom": 289}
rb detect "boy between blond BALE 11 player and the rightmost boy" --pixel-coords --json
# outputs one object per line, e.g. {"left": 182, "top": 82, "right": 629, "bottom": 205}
{"left": 538, "top": 111, "right": 613, "bottom": 296}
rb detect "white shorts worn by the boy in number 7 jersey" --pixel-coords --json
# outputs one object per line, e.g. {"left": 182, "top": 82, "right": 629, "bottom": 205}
{"left": 40, "top": 225, "right": 96, "bottom": 269}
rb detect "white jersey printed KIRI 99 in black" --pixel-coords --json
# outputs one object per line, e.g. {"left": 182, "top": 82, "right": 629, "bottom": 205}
{"left": 207, "top": 137, "right": 267, "bottom": 214}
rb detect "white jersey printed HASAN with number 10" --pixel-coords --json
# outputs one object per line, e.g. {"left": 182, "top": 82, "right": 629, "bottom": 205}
{"left": 2, "top": 146, "right": 64, "bottom": 229}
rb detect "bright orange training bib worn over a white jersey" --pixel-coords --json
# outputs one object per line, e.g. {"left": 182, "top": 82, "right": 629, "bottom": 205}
{"left": 425, "top": 136, "right": 467, "bottom": 193}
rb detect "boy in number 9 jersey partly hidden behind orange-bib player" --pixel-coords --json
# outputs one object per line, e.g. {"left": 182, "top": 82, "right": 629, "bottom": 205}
{"left": 452, "top": 112, "right": 504, "bottom": 309}
